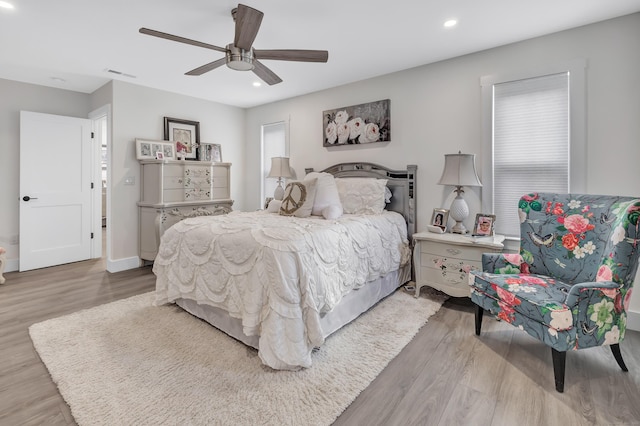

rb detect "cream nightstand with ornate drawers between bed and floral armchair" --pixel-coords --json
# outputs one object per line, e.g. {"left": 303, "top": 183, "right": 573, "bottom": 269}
{"left": 413, "top": 232, "right": 504, "bottom": 297}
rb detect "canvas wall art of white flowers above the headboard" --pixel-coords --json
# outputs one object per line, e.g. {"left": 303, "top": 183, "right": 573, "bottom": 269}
{"left": 322, "top": 99, "right": 391, "bottom": 147}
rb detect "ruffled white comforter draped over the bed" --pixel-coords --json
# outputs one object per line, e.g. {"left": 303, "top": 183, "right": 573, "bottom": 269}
{"left": 153, "top": 211, "right": 410, "bottom": 369}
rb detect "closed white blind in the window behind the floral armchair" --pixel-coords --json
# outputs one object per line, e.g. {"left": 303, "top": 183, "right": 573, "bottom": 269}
{"left": 492, "top": 72, "right": 570, "bottom": 237}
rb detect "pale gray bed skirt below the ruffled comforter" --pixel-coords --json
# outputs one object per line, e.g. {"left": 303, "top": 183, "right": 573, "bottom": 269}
{"left": 175, "top": 263, "right": 411, "bottom": 349}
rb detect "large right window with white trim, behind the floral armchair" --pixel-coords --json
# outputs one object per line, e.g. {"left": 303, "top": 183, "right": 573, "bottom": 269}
{"left": 482, "top": 60, "right": 585, "bottom": 237}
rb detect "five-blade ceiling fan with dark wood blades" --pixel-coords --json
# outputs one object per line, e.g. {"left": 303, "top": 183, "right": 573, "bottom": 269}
{"left": 140, "top": 4, "right": 329, "bottom": 85}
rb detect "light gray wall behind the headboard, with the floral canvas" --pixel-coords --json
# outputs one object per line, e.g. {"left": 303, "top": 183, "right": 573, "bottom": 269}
{"left": 245, "top": 13, "right": 640, "bottom": 329}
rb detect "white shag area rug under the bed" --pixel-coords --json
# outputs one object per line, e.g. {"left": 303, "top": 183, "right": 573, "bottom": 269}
{"left": 29, "top": 289, "right": 445, "bottom": 425}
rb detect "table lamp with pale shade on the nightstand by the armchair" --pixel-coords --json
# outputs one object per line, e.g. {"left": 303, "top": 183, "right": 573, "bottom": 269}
{"left": 438, "top": 151, "right": 482, "bottom": 234}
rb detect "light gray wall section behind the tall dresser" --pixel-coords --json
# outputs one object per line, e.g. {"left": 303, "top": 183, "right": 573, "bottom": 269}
{"left": 105, "top": 81, "right": 245, "bottom": 269}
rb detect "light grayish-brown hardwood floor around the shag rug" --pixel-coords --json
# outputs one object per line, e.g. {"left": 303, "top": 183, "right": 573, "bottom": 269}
{"left": 0, "top": 260, "right": 640, "bottom": 426}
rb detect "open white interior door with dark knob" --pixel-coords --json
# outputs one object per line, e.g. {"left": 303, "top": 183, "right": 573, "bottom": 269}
{"left": 19, "top": 111, "right": 92, "bottom": 271}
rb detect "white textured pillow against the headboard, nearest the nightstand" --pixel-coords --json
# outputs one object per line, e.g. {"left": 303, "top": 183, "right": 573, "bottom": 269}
{"left": 335, "top": 178, "right": 387, "bottom": 214}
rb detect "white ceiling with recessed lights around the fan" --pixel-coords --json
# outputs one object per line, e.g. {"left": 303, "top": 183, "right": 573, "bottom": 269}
{"left": 0, "top": 0, "right": 640, "bottom": 107}
